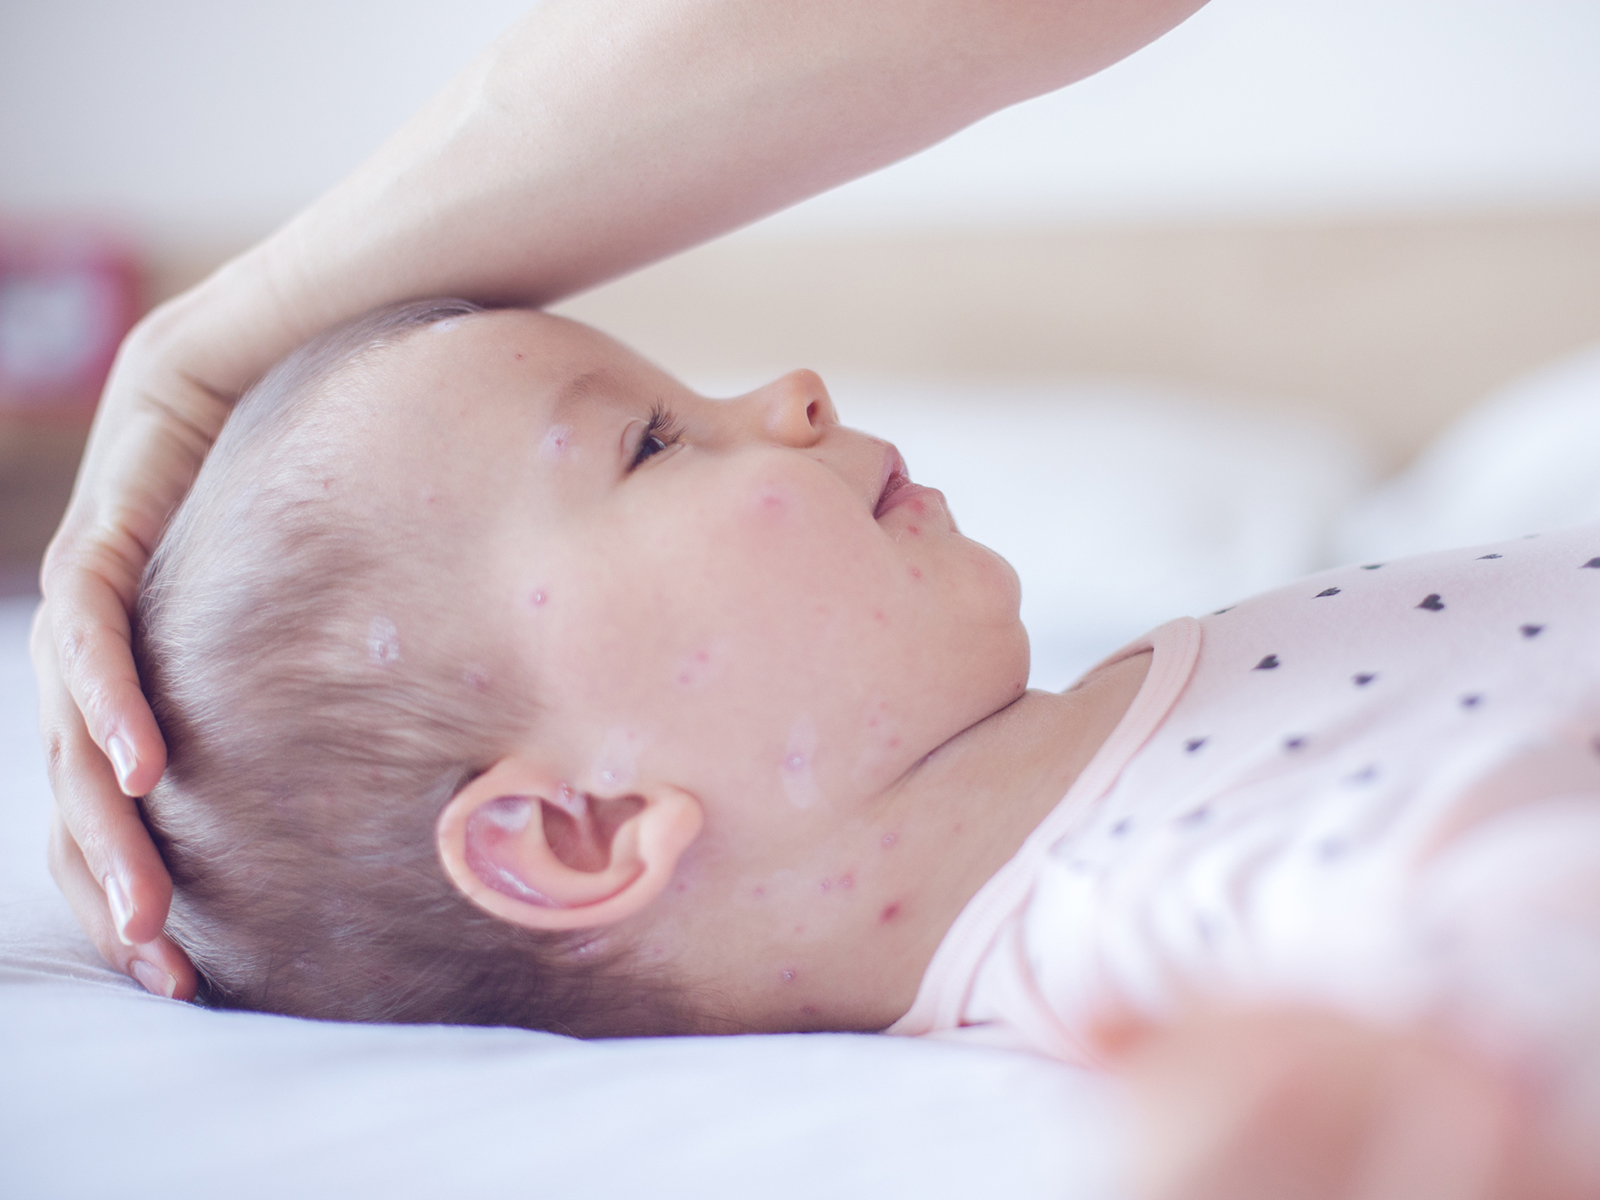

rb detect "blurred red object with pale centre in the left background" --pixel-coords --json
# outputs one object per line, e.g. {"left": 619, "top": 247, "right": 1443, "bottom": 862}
{"left": 0, "top": 221, "right": 142, "bottom": 421}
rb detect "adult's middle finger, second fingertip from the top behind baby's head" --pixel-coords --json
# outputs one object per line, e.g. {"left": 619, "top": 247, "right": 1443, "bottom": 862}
{"left": 34, "top": 602, "right": 173, "bottom": 960}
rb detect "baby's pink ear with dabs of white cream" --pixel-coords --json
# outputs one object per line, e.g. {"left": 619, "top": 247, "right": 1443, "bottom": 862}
{"left": 435, "top": 755, "right": 702, "bottom": 930}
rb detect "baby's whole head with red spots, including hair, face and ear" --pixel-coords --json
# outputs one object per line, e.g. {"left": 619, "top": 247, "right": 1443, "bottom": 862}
{"left": 136, "top": 301, "right": 1027, "bottom": 1034}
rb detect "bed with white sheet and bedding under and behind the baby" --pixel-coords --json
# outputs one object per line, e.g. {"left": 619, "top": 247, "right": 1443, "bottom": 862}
{"left": 9, "top": 211, "right": 1600, "bottom": 1200}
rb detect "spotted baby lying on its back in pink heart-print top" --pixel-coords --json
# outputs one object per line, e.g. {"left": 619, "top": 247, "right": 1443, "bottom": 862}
{"left": 136, "top": 301, "right": 1600, "bottom": 1177}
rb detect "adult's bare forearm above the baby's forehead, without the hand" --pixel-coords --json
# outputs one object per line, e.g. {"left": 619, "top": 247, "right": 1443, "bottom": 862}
{"left": 156, "top": 0, "right": 1202, "bottom": 392}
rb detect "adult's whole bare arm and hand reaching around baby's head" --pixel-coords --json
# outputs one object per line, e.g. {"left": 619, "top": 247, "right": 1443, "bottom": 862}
{"left": 34, "top": 0, "right": 1203, "bottom": 995}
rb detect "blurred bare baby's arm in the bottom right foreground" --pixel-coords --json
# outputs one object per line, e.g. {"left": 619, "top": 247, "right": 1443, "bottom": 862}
{"left": 1114, "top": 1011, "right": 1587, "bottom": 1200}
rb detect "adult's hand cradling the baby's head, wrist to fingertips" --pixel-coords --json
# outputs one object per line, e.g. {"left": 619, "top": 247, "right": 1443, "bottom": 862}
{"left": 32, "top": 264, "right": 308, "bottom": 998}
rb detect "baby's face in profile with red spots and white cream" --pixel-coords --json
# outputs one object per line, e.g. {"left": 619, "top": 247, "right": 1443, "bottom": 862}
{"left": 358, "top": 310, "right": 1027, "bottom": 858}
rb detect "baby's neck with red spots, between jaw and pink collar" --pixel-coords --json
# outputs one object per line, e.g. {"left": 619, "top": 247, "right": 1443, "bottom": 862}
{"left": 684, "top": 653, "right": 1150, "bottom": 1030}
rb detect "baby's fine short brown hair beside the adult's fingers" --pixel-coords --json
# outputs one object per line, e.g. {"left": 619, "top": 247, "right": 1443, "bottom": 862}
{"left": 134, "top": 299, "right": 683, "bottom": 1035}
